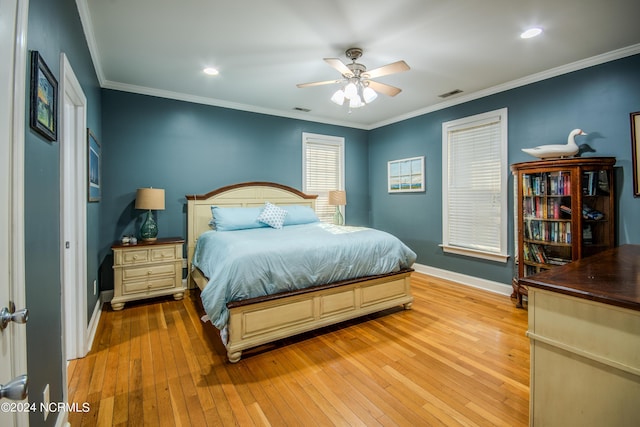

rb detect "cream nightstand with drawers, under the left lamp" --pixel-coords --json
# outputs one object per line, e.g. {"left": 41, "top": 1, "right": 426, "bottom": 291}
{"left": 111, "top": 237, "right": 186, "bottom": 310}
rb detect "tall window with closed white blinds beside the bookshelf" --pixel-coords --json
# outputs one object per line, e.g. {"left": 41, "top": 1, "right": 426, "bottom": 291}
{"left": 442, "top": 108, "right": 508, "bottom": 262}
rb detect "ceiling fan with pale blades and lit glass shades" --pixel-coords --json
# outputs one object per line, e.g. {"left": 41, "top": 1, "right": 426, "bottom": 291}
{"left": 297, "top": 47, "right": 409, "bottom": 108}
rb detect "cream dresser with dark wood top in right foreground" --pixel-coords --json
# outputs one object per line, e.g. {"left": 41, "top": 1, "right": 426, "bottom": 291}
{"left": 521, "top": 245, "right": 640, "bottom": 427}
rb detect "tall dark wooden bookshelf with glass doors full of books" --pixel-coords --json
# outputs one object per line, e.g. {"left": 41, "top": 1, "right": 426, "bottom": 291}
{"left": 511, "top": 157, "right": 616, "bottom": 306}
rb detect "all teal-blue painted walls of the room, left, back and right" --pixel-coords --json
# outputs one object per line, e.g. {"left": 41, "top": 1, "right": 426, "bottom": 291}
{"left": 20, "top": 0, "right": 640, "bottom": 426}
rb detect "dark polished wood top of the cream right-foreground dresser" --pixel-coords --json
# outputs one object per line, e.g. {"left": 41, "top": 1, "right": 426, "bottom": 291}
{"left": 520, "top": 245, "right": 640, "bottom": 311}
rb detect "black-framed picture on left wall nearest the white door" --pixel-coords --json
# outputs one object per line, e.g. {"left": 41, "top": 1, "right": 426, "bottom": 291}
{"left": 29, "top": 51, "right": 58, "bottom": 141}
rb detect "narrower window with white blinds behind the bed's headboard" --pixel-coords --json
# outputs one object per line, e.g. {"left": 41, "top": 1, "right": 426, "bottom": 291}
{"left": 302, "top": 132, "right": 344, "bottom": 222}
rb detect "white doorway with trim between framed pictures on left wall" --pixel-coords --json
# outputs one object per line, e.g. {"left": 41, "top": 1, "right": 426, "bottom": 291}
{"left": 60, "top": 52, "right": 88, "bottom": 366}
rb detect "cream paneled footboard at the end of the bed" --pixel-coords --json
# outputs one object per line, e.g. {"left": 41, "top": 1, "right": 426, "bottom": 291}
{"left": 227, "top": 269, "right": 413, "bottom": 363}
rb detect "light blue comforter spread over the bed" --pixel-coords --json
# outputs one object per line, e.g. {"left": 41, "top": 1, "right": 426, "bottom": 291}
{"left": 193, "top": 222, "right": 416, "bottom": 329}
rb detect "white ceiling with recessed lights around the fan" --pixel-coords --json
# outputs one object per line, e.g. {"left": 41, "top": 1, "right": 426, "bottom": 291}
{"left": 77, "top": 0, "right": 640, "bottom": 129}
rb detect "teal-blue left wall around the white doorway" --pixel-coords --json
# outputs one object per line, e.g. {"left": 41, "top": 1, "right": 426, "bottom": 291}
{"left": 24, "top": 0, "right": 101, "bottom": 426}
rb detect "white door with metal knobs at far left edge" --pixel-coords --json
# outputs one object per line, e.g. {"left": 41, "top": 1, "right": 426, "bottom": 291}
{"left": 0, "top": 0, "right": 28, "bottom": 426}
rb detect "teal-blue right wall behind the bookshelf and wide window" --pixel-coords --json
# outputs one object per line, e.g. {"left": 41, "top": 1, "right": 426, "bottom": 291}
{"left": 369, "top": 55, "right": 640, "bottom": 284}
